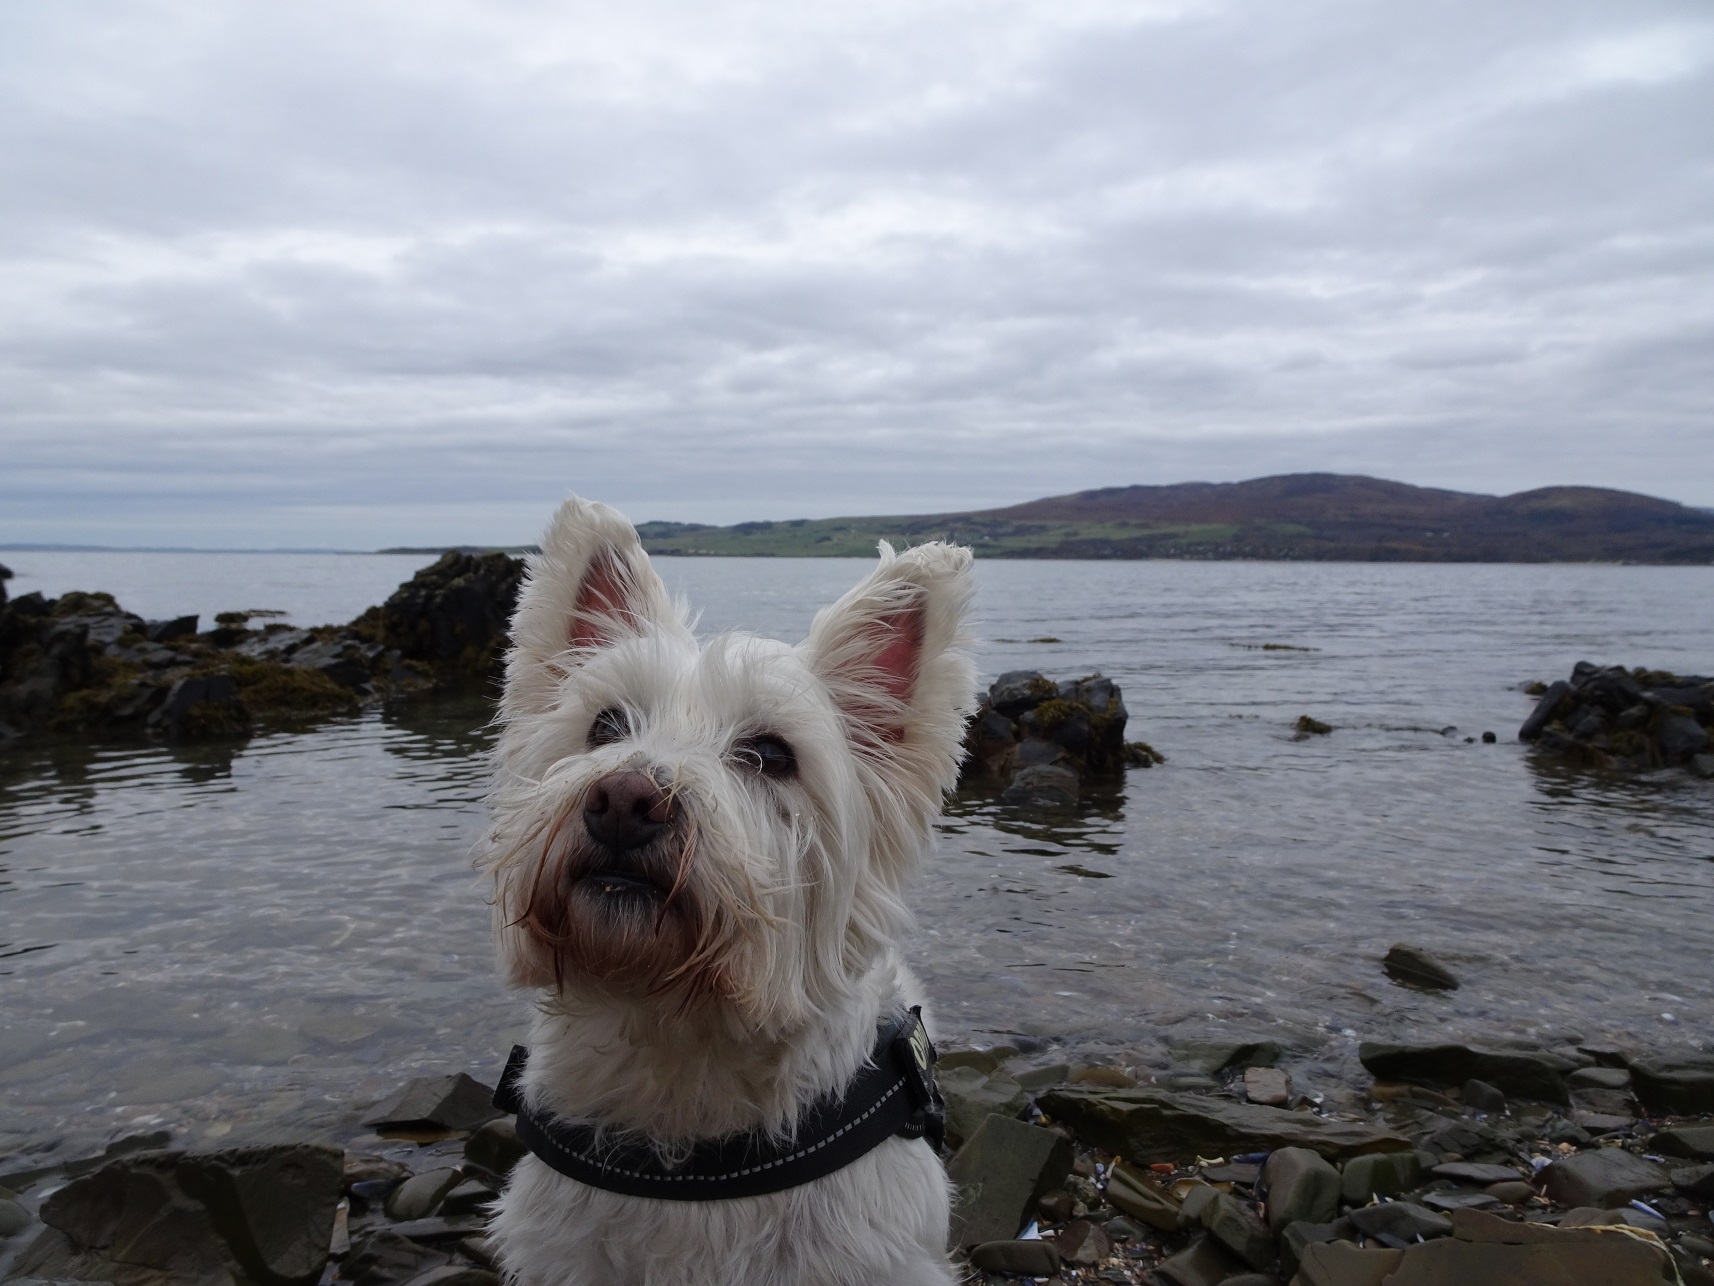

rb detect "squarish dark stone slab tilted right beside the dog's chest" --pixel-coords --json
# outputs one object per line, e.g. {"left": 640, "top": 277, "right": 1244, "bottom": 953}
{"left": 946, "top": 1116, "right": 1071, "bottom": 1247}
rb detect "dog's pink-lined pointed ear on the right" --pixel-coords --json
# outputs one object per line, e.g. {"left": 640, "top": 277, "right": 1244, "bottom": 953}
{"left": 804, "top": 542, "right": 975, "bottom": 814}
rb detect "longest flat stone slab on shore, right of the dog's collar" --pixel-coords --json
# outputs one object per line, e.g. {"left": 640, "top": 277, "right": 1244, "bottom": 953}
{"left": 1040, "top": 1085, "right": 1411, "bottom": 1161}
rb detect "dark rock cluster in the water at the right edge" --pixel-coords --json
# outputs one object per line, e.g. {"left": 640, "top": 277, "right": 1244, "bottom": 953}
{"left": 1517, "top": 660, "right": 1714, "bottom": 777}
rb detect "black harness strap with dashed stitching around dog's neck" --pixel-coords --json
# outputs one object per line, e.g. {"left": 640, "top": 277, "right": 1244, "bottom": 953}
{"left": 494, "top": 1007, "right": 946, "bottom": 1202}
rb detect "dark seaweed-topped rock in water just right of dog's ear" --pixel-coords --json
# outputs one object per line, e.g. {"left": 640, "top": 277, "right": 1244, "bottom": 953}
{"left": 960, "top": 670, "right": 1162, "bottom": 809}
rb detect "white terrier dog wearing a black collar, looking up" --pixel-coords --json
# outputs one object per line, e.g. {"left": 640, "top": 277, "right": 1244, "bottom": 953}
{"left": 485, "top": 499, "right": 975, "bottom": 1286}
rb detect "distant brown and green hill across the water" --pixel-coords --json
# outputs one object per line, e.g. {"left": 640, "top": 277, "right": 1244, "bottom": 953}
{"left": 638, "top": 473, "right": 1714, "bottom": 564}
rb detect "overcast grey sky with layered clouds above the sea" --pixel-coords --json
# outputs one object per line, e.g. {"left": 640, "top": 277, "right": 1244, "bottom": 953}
{"left": 0, "top": 0, "right": 1714, "bottom": 549}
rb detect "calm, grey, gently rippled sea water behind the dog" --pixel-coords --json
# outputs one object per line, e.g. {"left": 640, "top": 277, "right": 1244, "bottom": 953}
{"left": 0, "top": 559, "right": 1714, "bottom": 1172}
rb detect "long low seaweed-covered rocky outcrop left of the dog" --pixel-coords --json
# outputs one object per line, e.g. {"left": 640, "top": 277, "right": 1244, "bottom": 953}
{"left": 0, "top": 554, "right": 523, "bottom": 742}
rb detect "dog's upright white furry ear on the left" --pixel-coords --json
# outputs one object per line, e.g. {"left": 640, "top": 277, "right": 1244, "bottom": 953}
{"left": 506, "top": 496, "right": 689, "bottom": 717}
